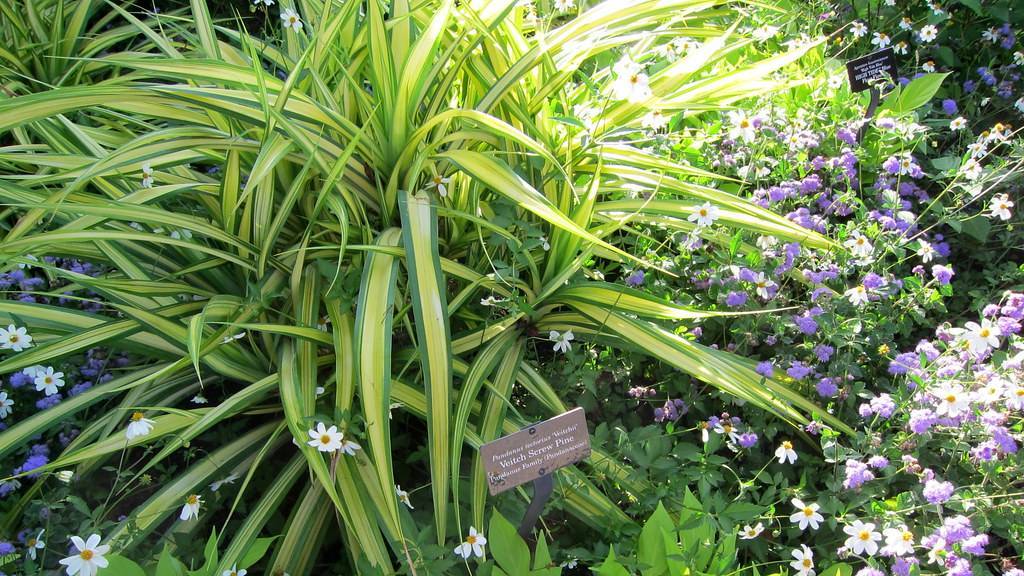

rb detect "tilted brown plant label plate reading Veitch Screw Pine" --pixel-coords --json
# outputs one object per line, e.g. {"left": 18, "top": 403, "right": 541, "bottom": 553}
{"left": 480, "top": 408, "right": 590, "bottom": 496}
